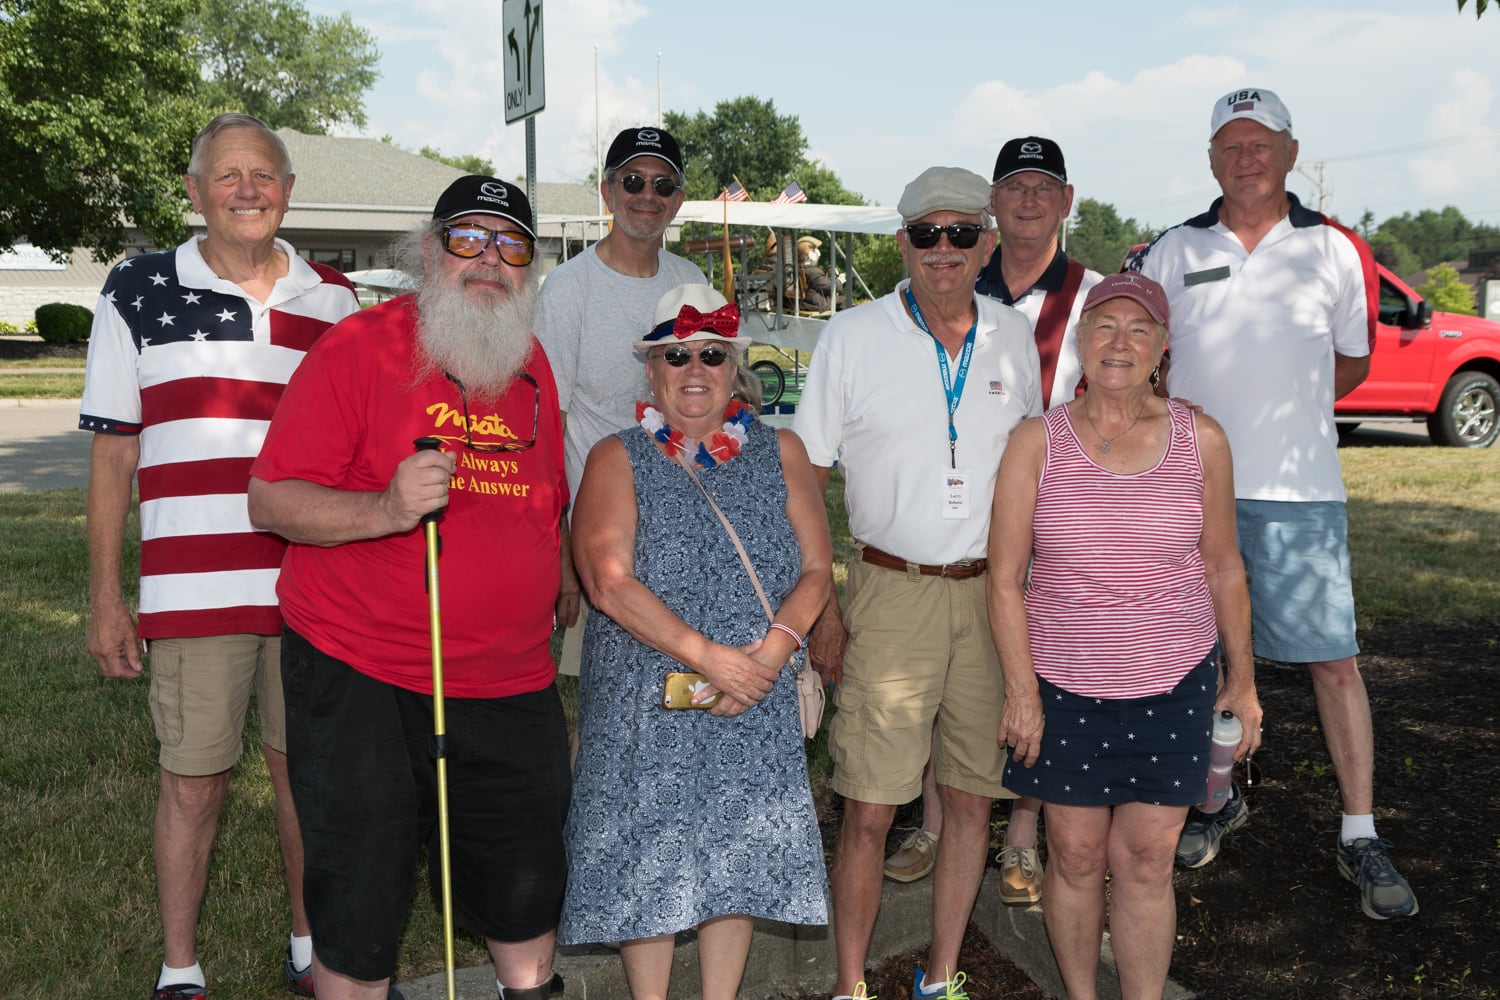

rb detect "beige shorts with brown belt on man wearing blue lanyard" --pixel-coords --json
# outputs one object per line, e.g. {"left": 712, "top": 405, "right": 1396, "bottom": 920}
{"left": 828, "top": 562, "right": 1016, "bottom": 805}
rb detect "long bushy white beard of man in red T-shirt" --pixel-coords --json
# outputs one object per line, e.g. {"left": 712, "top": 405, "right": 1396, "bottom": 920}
{"left": 414, "top": 277, "right": 539, "bottom": 403}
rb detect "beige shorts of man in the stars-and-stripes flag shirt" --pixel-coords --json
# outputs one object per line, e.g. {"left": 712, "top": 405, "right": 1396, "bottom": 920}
{"left": 149, "top": 634, "right": 287, "bottom": 777}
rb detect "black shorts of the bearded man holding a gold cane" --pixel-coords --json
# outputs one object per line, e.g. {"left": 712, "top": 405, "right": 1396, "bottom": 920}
{"left": 282, "top": 628, "right": 572, "bottom": 981}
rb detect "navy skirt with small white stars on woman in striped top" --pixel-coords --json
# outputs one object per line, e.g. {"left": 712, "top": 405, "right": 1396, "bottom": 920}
{"left": 1005, "top": 646, "right": 1218, "bottom": 805}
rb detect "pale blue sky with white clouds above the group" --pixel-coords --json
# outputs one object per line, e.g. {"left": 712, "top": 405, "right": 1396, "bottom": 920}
{"left": 305, "top": 0, "right": 1500, "bottom": 228}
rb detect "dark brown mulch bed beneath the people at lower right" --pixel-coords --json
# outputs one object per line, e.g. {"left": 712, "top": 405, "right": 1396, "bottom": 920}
{"left": 788, "top": 622, "right": 1500, "bottom": 1000}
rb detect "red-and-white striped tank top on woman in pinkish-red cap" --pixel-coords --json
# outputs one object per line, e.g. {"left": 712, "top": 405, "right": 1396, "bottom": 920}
{"left": 1026, "top": 402, "right": 1218, "bottom": 699}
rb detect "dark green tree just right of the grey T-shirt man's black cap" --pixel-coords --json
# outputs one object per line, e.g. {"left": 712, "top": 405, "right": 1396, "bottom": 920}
{"left": 665, "top": 96, "right": 807, "bottom": 201}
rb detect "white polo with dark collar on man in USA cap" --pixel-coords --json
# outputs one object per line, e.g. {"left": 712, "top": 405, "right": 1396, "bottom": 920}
{"left": 1136, "top": 195, "right": 1380, "bottom": 501}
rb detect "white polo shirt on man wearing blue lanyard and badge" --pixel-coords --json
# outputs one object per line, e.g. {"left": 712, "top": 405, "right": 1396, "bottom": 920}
{"left": 792, "top": 282, "right": 1041, "bottom": 564}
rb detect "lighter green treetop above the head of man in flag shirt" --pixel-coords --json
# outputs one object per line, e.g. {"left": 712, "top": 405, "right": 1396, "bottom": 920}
{"left": 189, "top": 0, "right": 380, "bottom": 133}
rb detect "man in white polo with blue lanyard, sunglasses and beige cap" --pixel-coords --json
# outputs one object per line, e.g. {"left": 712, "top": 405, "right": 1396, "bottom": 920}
{"left": 794, "top": 166, "right": 1041, "bottom": 997}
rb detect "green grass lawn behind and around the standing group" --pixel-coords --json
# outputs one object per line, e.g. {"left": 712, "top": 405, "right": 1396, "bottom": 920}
{"left": 0, "top": 447, "right": 1500, "bottom": 1000}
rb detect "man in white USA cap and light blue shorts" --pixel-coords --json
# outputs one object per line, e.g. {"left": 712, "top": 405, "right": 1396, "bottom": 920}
{"left": 1131, "top": 87, "right": 1418, "bottom": 921}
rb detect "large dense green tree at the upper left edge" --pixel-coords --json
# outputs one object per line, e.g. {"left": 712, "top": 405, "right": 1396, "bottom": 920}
{"left": 0, "top": 0, "right": 206, "bottom": 259}
